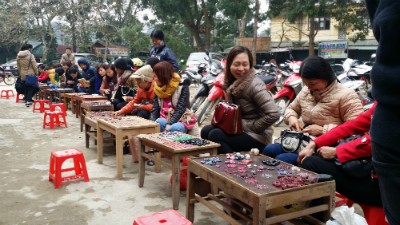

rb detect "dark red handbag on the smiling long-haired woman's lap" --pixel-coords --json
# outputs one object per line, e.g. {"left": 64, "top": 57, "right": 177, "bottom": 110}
{"left": 211, "top": 102, "right": 243, "bottom": 134}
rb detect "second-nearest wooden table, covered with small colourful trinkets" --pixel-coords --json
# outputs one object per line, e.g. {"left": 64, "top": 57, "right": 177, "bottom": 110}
{"left": 138, "top": 132, "right": 220, "bottom": 210}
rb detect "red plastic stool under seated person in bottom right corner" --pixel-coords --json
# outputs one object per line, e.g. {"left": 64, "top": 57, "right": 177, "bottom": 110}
{"left": 335, "top": 192, "right": 389, "bottom": 225}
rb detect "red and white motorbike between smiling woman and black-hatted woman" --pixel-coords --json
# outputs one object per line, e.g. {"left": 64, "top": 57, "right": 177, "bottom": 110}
{"left": 273, "top": 61, "right": 303, "bottom": 127}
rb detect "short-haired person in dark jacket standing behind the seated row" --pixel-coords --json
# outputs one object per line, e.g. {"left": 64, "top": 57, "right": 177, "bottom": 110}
{"left": 150, "top": 30, "right": 179, "bottom": 72}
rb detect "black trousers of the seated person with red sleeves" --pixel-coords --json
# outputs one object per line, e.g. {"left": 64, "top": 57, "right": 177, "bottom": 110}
{"left": 300, "top": 155, "right": 382, "bottom": 207}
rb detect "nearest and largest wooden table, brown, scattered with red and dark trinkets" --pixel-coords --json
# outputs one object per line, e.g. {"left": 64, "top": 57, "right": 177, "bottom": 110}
{"left": 186, "top": 155, "right": 335, "bottom": 225}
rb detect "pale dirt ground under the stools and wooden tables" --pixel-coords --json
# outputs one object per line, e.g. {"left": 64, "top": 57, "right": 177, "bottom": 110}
{"left": 0, "top": 84, "right": 362, "bottom": 225}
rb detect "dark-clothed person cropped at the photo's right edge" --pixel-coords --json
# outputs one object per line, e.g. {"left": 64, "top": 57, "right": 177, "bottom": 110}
{"left": 365, "top": 0, "right": 400, "bottom": 225}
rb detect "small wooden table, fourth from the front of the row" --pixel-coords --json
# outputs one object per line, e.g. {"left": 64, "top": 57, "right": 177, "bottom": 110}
{"left": 84, "top": 111, "right": 114, "bottom": 148}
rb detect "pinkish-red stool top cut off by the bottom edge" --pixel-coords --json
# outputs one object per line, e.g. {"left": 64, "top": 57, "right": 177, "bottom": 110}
{"left": 133, "top": 209, "right": 192, "bottom": 225}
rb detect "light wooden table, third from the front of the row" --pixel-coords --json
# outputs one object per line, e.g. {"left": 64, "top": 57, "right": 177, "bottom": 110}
{"left": 97, "top": 116, "right": 160, "bottom": 178}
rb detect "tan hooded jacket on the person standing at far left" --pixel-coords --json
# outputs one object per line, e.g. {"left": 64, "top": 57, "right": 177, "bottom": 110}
{"left": 17, "top": 50, "right": 38, "bottom": 80}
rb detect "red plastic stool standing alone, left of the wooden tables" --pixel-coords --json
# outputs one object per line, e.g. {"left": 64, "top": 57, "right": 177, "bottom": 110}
{"left": 49, "top": 149, "right": 89, "bottom": 188}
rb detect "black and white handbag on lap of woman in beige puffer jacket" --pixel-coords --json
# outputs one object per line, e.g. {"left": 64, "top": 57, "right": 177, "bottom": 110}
{"left": 274, "top": 130, "right": 312, "bottom": 153}
